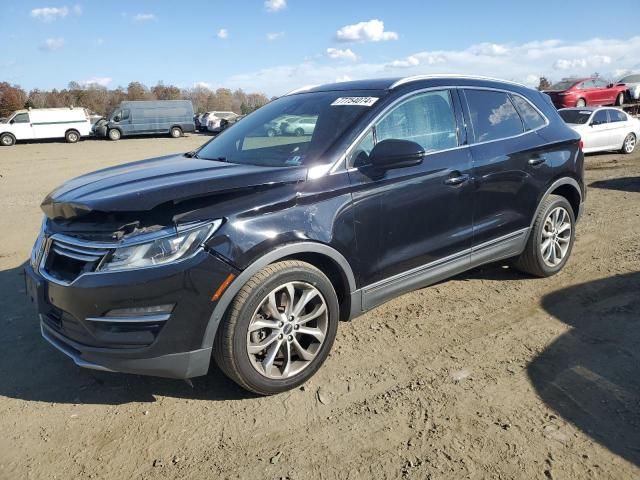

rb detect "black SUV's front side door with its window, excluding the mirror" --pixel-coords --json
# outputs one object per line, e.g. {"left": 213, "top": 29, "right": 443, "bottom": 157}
{"left": 347, "top": 90, "right": 473, "bottom": 308}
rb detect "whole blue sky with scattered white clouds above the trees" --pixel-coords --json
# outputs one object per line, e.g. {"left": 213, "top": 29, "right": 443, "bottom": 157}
{"left": 0, "top": 0, "right": 640, "bottom": 95}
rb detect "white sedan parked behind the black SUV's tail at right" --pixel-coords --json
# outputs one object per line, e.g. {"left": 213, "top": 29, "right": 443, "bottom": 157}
{"left": 558, "top": 107, "right": 640, "bottom": 153}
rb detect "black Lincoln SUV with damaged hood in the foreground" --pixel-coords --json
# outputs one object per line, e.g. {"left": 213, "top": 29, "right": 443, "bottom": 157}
{"left": 26, "top": 76, "right": 585, "bottom": 394}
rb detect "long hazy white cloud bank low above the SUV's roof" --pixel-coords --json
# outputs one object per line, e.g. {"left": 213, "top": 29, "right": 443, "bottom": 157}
{"left": 222, "top": 36, "right": 640, "bottom": 95}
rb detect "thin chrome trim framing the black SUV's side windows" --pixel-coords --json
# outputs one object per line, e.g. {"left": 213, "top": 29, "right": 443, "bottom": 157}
{"left": 329, "top": 84, "right": 551, "bottom": 175}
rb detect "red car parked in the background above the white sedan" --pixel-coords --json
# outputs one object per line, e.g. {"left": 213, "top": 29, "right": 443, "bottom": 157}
{"left": 544, "top": 78, "right": 627, "bottom": 108}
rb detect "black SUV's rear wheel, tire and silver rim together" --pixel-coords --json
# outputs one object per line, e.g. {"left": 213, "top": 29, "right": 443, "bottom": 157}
{"left": 515, "top": 195, "right": 576, "bottom": 277}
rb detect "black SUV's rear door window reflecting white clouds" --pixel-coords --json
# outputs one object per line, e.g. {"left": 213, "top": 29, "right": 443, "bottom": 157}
{"left": 465, "top": 90, "right": 524, "bottom": 142}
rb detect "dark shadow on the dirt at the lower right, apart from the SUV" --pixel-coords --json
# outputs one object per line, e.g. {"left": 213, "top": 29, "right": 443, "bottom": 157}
{"left": 527, "top": 272, "right": 640, "bottom": 465}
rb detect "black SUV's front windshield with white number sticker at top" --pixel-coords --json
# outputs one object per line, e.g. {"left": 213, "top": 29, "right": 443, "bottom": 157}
{"left": 197, "top": 91, "right": 380, "bottom": 167}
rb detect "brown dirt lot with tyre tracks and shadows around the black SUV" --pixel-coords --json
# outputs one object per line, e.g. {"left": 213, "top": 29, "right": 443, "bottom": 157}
{"left": 0, "top": 135, "right": 640, "bottom": 480}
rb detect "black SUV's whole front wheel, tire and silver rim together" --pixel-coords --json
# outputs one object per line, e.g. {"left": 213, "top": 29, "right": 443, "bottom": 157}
{"left": 214, "top": 260, "right": 339, "bottom": 395}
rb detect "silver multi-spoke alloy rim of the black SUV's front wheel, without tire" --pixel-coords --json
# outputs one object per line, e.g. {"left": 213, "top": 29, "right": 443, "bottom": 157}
{"left": 247, "top": 282, "right": 329, "bottom": 379}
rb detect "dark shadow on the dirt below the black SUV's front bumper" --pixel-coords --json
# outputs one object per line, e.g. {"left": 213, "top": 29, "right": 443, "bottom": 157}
{"left": 0, "top": 266, "right": 252, "bottom": 405}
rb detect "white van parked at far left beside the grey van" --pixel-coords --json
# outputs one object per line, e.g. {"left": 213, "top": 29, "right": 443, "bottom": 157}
{"left": 0, "top": 108, "right": 91, "bottom": 147}
